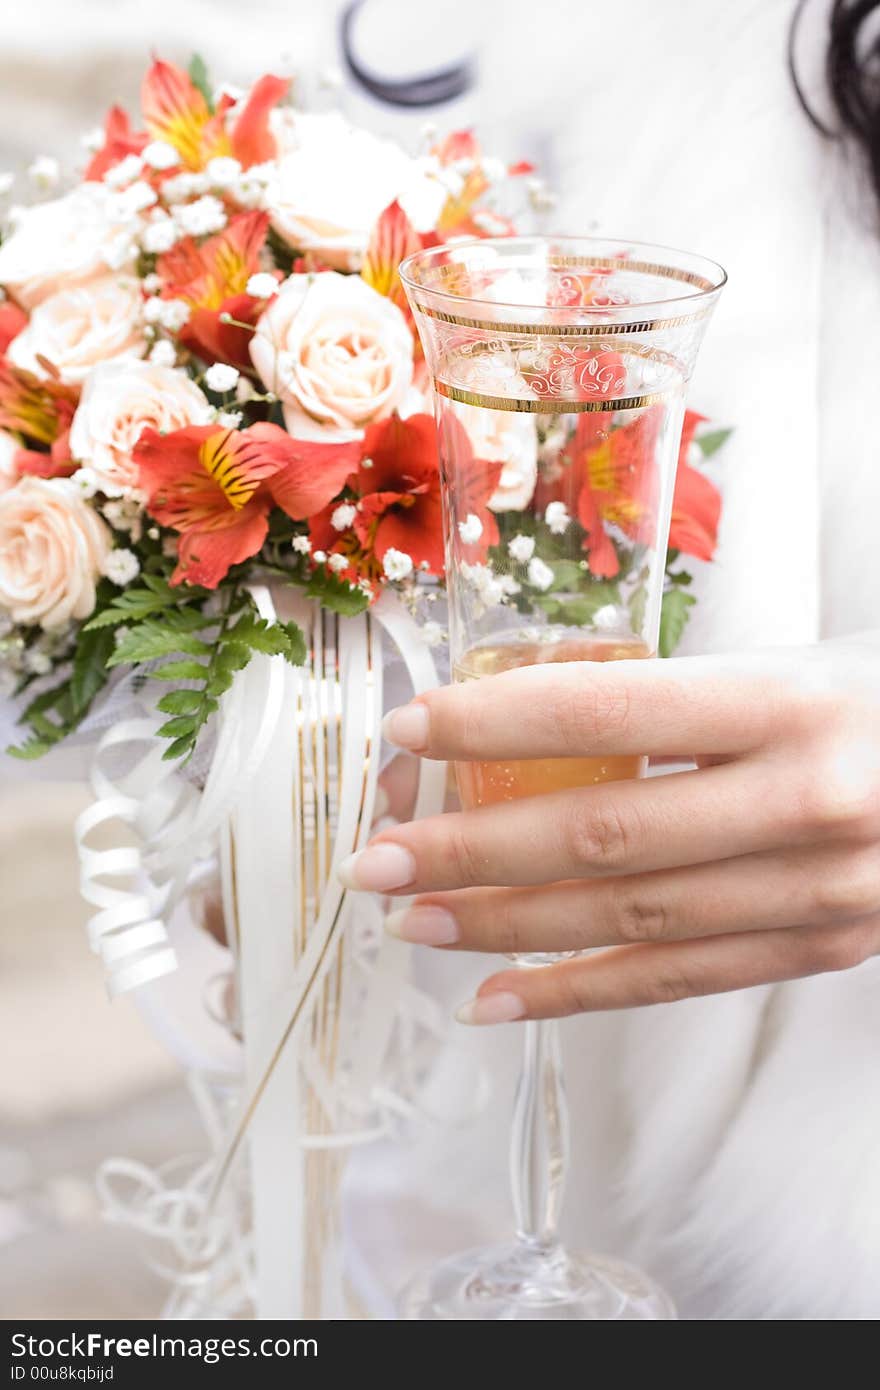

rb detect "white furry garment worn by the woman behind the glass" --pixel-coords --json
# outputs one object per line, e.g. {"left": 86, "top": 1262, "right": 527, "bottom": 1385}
{"left": 348, "top": 0, "right": 880, "bottom": 1319}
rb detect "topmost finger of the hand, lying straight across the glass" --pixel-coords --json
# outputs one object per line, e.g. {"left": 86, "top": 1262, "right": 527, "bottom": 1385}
{"left": 382, "top": 653, "right": 787, "bottom": 760}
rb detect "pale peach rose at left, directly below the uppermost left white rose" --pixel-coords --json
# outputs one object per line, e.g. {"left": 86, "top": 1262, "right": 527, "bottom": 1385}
{"left": 7, "top": 275, "right": 147, "bottom": 385}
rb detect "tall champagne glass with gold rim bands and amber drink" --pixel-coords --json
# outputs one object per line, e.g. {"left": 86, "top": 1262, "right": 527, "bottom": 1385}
{"left": 400, "top": 236, "right": 726, "bottom": 1321}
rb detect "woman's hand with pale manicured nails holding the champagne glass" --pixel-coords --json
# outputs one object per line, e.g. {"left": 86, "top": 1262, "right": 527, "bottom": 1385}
{"left": 336, "top": 637, "right": 880, "bottom": 1023}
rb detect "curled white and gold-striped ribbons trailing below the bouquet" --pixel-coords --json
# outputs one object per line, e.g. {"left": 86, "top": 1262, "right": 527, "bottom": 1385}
{"left": 83, "top": 589, "right": 487, "bottom": 1316}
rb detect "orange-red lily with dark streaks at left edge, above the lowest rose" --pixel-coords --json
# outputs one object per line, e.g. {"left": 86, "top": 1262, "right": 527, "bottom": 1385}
{"left": 0, "top": 359, "right": 79, "bottom": 478}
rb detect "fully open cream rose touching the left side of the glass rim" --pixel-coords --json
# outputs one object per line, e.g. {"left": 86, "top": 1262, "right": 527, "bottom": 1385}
{"left": 250, "top": 271, "right": 413, "bottom": 439}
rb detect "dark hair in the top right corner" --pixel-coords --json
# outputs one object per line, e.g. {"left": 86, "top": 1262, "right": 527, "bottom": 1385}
{"left": 788, "top": 0, "right": 880, "bottom": 208}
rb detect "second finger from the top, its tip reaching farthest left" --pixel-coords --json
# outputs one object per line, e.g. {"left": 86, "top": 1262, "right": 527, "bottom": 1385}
{"left": 339, "top": 762, "right": 834, "bottom": 892}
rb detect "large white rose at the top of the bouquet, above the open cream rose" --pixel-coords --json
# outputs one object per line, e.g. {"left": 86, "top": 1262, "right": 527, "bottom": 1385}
{"left": 271, "top": 111, "right": 446, "bottom": 270}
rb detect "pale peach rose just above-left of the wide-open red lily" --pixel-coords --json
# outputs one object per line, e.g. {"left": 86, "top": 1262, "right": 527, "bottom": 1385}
{"left": 71, "top": 360, "right": 211, "bottom": 498}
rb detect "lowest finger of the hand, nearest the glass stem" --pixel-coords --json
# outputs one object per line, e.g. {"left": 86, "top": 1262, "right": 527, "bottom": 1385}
{"left": 456, "top": 916, "right": 880, "bottom": 1023}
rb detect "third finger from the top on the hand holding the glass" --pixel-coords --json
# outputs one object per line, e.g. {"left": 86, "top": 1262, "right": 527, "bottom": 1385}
{"left": 385, "top": 848, "right": 880, "bottom": 955}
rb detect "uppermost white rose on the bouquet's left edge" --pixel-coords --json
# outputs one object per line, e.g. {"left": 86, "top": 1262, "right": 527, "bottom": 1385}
{"left": 0, "top": 183, "right": 133, "bottom": 309}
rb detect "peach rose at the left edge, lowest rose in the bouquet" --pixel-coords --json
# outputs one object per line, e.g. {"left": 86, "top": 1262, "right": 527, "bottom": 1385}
{"left": 0, "top": 478, "right": 113, "bottom": 631}
